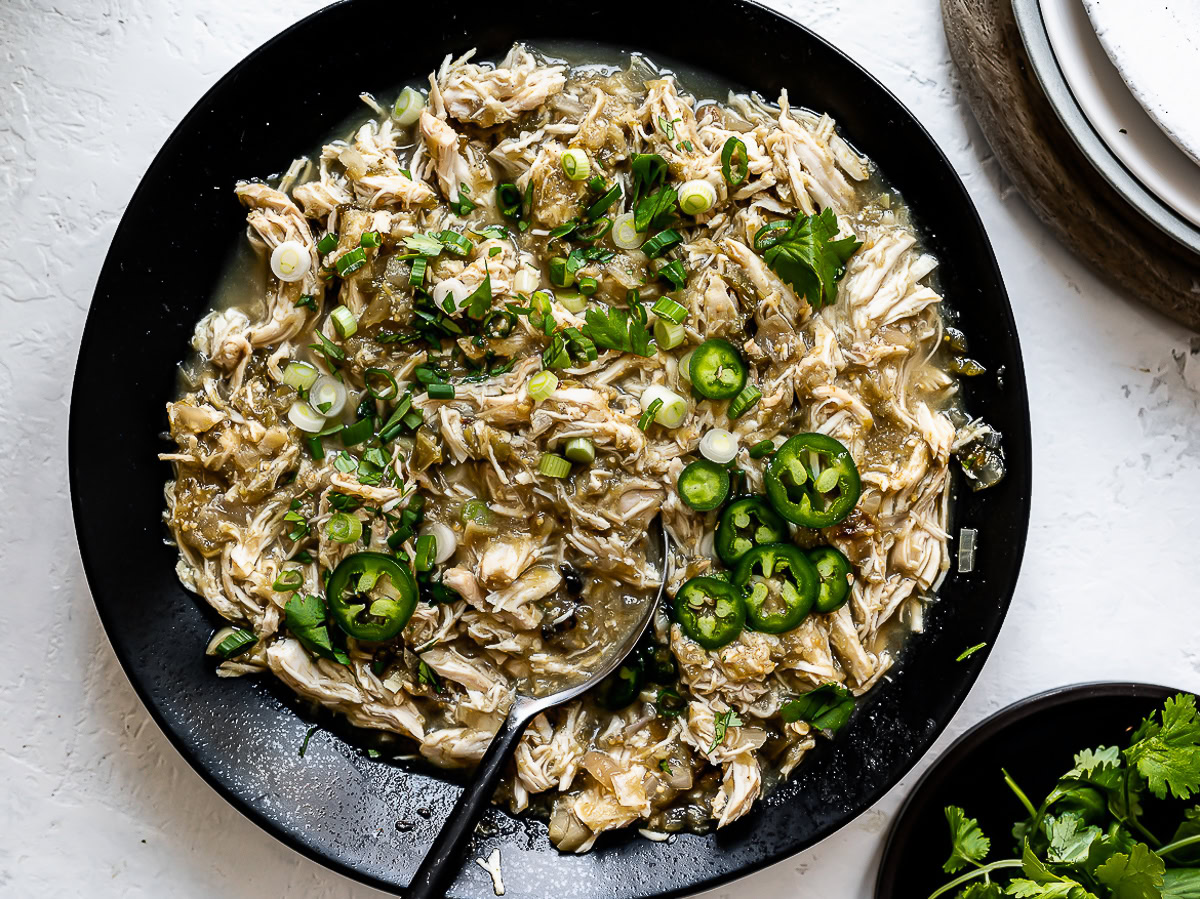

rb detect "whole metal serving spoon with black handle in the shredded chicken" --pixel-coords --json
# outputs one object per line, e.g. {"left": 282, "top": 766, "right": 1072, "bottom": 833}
{"left": 406, "top": 522, "right": 668, "bottom": 899}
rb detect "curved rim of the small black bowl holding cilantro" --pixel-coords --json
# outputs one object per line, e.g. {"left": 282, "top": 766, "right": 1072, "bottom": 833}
{"left": 875, "top": 681, "right": 1192, "bottom": 899}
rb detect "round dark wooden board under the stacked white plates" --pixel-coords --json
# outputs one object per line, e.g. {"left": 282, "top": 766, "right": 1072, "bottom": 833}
{"left": 942, "top": 0, "right": 1200, "bottom": 330}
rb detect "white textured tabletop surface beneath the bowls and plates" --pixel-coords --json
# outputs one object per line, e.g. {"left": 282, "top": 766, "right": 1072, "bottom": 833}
{"left": 7, "top": 0, "right": 1200, "bottom": 899}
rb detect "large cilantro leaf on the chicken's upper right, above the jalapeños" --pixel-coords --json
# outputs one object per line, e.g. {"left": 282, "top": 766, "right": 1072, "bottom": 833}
{"left": 754, "top": 208, "right": 863, "bottom": 308}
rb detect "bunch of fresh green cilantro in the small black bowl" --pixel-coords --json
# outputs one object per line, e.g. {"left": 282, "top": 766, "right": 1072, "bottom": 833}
{"left": 930, "top": 694, "right": 1200, "bottom": 899}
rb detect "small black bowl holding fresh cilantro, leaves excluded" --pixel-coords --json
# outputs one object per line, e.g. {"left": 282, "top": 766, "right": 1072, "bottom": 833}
{"left": 875, "top": 682, "right": 1189, "bottom": 899}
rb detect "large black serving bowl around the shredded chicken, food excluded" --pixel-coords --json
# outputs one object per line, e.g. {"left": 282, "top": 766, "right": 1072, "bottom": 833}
{"left": 70, "top": 0, "right": 1031, "bottom": 899}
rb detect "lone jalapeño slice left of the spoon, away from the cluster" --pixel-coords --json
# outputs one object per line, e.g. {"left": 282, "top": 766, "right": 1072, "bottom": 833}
{"left": 325, "top": 552, "right": 416, "bottom": 642}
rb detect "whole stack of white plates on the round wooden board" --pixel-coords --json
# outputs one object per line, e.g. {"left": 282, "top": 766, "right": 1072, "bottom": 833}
{"left": 1013, "top": 0, "right": 1200, "bottom": 253}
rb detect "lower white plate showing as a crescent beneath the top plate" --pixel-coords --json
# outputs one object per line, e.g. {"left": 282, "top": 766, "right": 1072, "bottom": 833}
{"left": 1040, "top": 0, "right": 1200, "bottom": 226}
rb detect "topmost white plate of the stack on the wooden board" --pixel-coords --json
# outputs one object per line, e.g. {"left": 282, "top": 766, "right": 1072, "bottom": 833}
{"left": 1084, "top": 0, "right": 1200, "bottom": 163}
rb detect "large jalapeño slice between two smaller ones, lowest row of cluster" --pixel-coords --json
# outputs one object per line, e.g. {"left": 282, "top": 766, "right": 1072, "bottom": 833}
{"left": 733, "top": 544, "right": 821, "bottom": 634}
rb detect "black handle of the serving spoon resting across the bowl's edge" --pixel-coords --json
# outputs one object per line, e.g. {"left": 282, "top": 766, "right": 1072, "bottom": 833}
{"left": 404, "top": 700, "right": 530, "bottom": 899}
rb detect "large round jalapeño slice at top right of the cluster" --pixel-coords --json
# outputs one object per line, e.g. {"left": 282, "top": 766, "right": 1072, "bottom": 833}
{"left": 764, "top": 433, "right": 862, "bottom": 528}
